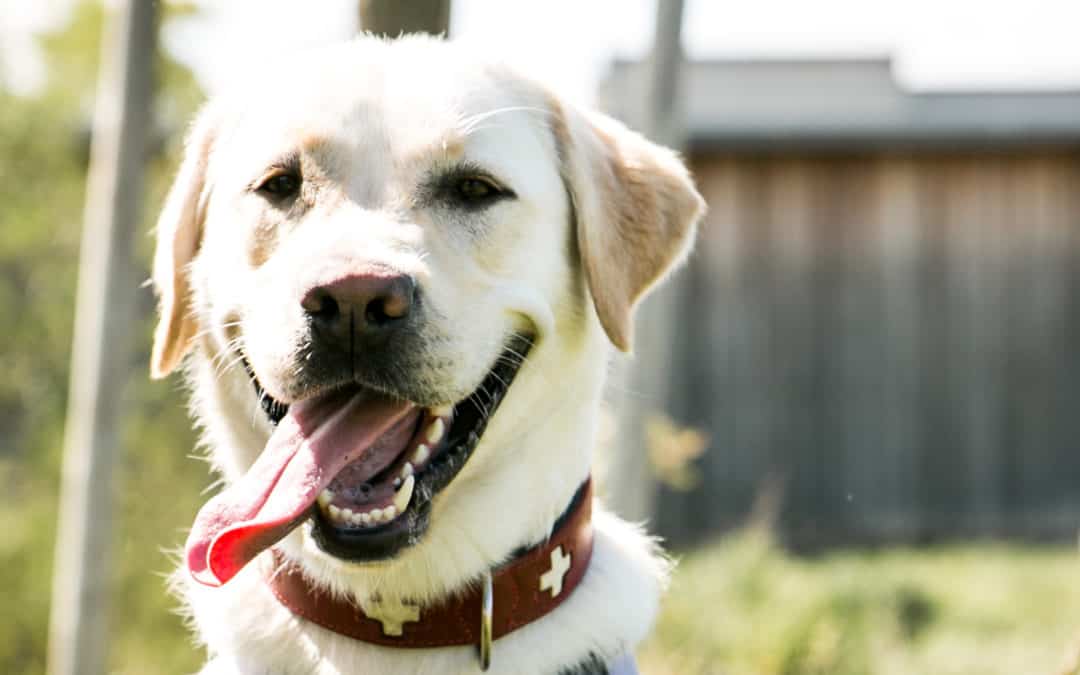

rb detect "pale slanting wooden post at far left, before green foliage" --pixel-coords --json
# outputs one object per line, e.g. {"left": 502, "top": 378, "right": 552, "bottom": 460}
{"left": 47, "top": 0, "right": 157, "bottom": 675}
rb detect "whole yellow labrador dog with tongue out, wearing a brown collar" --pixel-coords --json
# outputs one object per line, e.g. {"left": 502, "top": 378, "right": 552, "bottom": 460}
{"left": 151, "top": 37, "right": 703, "bottom": 675}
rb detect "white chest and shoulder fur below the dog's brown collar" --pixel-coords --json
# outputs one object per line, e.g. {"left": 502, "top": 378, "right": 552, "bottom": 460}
{"left": 183, "top": 511, "right": 667, "bottom": 674}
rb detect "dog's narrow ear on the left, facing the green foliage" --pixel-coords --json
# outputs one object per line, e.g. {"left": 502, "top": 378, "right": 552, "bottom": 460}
{"left": 150, "top": 107, "right": 218, "bottom": 379}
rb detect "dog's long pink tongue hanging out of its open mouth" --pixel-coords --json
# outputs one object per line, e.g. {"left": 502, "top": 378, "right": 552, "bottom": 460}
{"left": 186, "top": 392, "right": 413, "bottom": 586}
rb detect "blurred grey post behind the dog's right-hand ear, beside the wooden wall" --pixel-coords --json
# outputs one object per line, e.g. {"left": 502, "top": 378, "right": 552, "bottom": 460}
{"left": 608, "top": 0, "right": 685, "bottom": 521}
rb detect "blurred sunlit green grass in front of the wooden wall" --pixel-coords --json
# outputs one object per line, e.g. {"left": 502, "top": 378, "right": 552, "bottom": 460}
{"left": 639, "top": 530, "right": 1080, "bottom": 675}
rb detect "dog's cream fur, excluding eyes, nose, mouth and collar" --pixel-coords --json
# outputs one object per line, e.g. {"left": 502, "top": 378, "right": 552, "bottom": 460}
{"left": 152, "top": 38, "right": 702, "bottom": 675}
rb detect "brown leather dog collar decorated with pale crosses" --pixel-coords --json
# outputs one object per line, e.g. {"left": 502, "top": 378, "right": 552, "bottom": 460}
{"left": 267, "top": 480, "right": 593, "bottom": 647}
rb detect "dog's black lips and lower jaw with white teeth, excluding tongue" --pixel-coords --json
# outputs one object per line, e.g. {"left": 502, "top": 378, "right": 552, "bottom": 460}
{"left": 245, "top": 336, "right": 532, "bottom": 563}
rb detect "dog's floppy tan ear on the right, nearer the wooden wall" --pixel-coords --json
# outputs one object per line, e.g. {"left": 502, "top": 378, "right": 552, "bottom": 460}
{"left": 552, "top": 103, "right": 705, "bottom": 352}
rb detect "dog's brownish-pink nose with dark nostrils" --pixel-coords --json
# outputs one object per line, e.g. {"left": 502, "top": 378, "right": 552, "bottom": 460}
{"left": 300, "top": 272, "right": 416, "bottom": 350}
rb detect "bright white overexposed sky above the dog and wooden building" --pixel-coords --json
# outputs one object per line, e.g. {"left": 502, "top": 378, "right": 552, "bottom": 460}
{"left": 0, "top": 0, "right": 1080, "bottom": 100}
